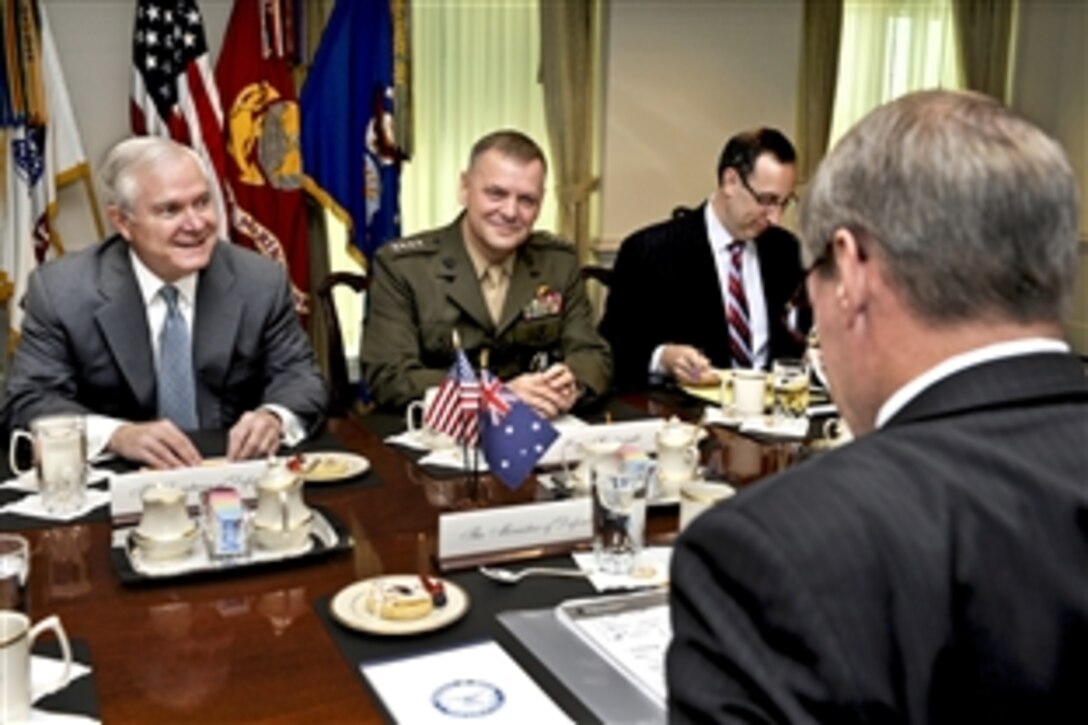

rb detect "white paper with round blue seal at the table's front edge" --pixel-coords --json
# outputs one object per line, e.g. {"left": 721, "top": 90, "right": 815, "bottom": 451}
{"left": 360, "top": 641, "right": 572, "bottom": 725}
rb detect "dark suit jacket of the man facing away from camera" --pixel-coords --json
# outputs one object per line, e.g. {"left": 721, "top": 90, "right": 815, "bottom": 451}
{"left": 668, "top": 354, "right": 1088, "bottom": 723}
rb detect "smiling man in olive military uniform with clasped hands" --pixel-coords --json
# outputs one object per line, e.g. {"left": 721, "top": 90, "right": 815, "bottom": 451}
{"left": 361, "top": 131, "right": 611, "bottom": 417}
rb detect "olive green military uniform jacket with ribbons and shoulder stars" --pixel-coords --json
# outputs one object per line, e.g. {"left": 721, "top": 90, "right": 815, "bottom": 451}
{"left": 361, "top": 217, "right": 613, "bottom": 408}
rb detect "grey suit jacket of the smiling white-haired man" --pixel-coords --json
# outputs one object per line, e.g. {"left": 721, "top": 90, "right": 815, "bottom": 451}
{"left": 4, "top": 236, "right": 326, "bottom": 431}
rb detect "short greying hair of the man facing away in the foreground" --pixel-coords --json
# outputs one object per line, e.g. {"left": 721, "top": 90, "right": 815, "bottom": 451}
{"left": 801, "top": 90, "right": 1077, "bottom": 323}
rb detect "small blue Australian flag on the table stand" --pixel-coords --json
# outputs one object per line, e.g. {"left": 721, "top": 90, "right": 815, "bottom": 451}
{"left": 480, "top": 370, "right": 559, "bottom": 489}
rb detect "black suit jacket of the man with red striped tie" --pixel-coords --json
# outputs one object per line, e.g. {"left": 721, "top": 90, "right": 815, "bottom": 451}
{"left": 601, "top": 205, "right": 803, "bottom": 388}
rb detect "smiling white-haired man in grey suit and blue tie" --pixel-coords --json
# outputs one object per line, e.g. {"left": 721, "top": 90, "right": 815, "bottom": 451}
{"left": 4, "top": 137, "right": 326, "bottom": 468}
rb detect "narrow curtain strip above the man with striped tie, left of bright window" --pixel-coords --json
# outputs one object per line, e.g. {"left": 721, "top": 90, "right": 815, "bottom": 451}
{"left": 796, "top": 0, "right": 843, "bottom": 184}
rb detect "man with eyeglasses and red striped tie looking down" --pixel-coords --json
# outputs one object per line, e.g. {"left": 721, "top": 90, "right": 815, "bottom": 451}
{"left": 601, "top": 128, "right": 804, "bottom": 389}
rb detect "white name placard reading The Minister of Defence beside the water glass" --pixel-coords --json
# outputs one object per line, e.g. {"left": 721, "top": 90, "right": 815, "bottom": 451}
{"left": 438, "top": 496, "right": 593, "bottom": 561}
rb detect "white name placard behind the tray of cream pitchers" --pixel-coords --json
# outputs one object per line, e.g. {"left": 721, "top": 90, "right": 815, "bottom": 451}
{"left": 110, "top": 460, "right": 268, "bottom": 521}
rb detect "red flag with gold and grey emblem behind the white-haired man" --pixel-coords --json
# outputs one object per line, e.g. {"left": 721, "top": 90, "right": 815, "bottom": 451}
{"left": 215, "top": 0, "right": 310, "bottom": 314}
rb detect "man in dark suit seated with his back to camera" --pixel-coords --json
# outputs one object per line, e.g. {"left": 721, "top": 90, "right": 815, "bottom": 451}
{"left": 667, "top": 90, "right": 1088, "bottom": 723}
